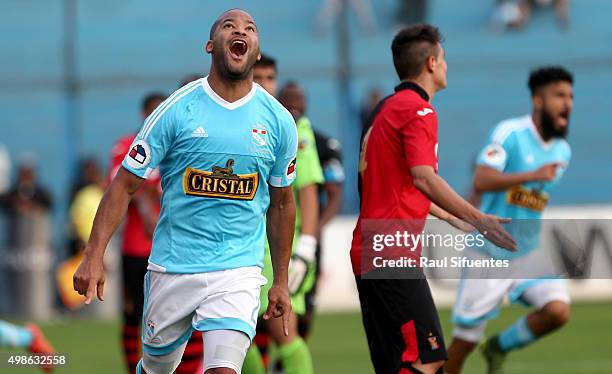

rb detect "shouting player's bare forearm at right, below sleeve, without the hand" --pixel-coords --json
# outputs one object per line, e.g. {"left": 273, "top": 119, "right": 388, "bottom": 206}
{"left": 266, "top": 195, "right": 295, "bottom": 286}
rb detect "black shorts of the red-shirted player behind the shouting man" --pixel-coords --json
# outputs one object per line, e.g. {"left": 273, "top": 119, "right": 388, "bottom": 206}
{"left": 121, "top": 255, "right": 149, "bottom": 325}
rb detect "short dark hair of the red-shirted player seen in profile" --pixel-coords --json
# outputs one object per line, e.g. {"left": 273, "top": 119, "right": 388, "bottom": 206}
{"left": 391, "top": 24, "right": 443, "bottom": 80}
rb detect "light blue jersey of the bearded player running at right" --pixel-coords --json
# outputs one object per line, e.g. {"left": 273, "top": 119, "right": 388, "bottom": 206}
{"left": 477, "top": 115, "right": 571, "bottom": 258}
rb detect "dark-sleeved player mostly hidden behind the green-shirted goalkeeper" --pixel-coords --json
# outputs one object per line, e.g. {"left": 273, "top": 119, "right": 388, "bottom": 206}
{"left": 298, "top": 129, "right": 344, "bottom": 339}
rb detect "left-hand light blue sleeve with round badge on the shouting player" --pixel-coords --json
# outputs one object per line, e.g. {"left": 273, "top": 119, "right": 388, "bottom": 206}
{"left": 121, "top": 102, "right": 176, "bottom": 179}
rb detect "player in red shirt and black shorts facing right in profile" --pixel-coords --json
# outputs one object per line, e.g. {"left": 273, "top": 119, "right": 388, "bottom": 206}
{"left": 351, "top": 25, "right": 516, "bottom": 374}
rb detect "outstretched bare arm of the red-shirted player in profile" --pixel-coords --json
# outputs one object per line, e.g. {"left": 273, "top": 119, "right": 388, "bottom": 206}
{"left": 410, "top": 165, "right": 516, "bottom": 251}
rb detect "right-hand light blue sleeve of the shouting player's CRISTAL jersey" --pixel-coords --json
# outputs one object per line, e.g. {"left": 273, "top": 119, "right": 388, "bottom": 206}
{"left": 268, "top": 113, "right": 298, "bottom": 187}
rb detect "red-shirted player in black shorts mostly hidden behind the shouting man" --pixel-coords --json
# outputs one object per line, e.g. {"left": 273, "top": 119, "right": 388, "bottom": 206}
{"left": 109, "top": 93, "right": 202, "bottom": 374}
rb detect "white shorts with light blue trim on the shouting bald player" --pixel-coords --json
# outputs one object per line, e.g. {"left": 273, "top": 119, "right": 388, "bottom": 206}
{"left": 142, "top": 266, "right": 266, "bottom": 356}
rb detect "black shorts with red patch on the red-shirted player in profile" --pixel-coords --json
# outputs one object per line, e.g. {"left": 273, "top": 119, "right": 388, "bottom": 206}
{"left": 355, "top": 276, "right": 447, "bottom": 374}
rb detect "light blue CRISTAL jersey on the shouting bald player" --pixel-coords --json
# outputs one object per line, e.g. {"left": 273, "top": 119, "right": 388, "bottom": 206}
{"left": 123, "top": 78, "right": 297, "bottom": 273}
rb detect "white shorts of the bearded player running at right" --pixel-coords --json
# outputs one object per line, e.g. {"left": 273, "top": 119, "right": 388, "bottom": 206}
{"left": 453, "top": 251, "right": 570, "bottom": 331}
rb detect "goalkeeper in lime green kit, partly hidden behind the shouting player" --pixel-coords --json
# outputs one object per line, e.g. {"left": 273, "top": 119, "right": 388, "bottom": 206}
{"left": 243, "top": 56, "right": 323, "bottom": 374}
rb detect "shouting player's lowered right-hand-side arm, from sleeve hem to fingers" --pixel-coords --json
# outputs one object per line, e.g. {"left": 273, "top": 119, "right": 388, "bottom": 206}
{"left": 264, "top": 186, "right": 295, "bottom": 335}
